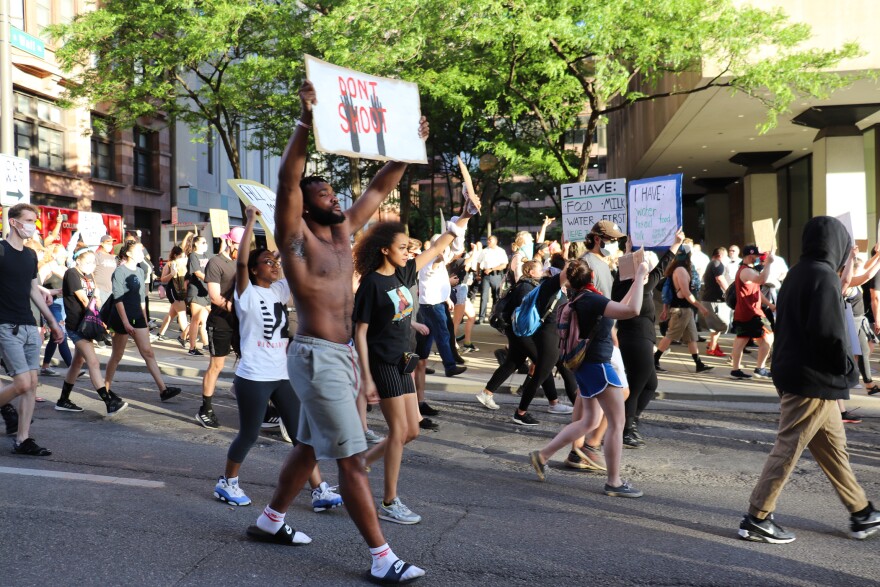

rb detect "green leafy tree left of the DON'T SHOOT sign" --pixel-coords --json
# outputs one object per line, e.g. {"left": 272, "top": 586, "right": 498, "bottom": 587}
{"left": 50, "top": 0, "right": 309, "bottom": 178}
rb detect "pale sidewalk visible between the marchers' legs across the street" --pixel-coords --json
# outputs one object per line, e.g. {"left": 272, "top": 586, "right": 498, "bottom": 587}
{"left": 97, "top": 294, "right": 880, "bottom": 416}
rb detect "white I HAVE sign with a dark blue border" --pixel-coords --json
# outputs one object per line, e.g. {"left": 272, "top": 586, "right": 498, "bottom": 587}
{"left": 627, "top": 173, "right": 682, "bottom": 247}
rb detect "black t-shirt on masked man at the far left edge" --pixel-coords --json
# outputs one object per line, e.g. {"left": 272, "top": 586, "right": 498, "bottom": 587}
{"left": 0, "top": 241, "right": 37, "bottom": 326}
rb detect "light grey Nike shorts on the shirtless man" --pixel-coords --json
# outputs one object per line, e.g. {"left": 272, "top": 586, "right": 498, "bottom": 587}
{"left": 287, "top": 335, "right": 367, "bottom": 461}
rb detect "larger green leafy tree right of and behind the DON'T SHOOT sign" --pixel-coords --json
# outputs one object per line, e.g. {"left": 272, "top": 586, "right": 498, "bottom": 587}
{"left": 315, "top": 0, "right": 859, "bottom": 184}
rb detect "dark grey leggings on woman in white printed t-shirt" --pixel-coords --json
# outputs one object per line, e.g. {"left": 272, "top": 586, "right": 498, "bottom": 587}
{"left": 226, "top": 375, "right": 299, "bottom": 464}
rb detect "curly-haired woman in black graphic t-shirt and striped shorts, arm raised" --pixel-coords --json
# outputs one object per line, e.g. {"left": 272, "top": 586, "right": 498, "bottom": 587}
{"left": 353, "top": 215, "right": 468, "bottom": 524}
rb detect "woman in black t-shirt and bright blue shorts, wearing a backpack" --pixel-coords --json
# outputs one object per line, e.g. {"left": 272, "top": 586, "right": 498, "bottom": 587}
{"left": 529, "top": 260, "right": 648, "bottom": 497}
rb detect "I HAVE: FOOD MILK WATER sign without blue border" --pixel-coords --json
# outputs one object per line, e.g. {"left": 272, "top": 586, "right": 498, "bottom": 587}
{"left": 561, "top": 179, "right": 627, "bottom": 242}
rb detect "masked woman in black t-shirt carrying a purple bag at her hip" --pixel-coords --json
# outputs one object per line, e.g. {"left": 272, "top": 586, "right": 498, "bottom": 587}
{"left": 55, "top": 248, "right": 128, "bottom": 416}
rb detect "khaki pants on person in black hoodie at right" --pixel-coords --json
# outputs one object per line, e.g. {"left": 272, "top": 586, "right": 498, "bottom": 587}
{"left": 749, "top": 393, "right": 868, "bottom": 519}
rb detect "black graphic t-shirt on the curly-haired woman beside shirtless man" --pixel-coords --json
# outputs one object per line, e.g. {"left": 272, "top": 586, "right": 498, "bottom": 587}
{"left": 353, "top": 260, "right": 418, "bottom": 365}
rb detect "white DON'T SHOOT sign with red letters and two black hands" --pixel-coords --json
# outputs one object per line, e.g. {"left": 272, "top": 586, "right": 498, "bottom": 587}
{"left": 306, "top": 55, "right": 428, "bottom": 163}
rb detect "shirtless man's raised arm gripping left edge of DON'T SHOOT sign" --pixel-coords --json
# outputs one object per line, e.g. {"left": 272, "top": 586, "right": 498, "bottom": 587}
{"left": 275, "top": 80, "right": 316, "bottom": 248}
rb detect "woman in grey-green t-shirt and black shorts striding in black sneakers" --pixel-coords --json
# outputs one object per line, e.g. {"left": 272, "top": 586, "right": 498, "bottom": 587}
{"left": 105, "top": 241, "right": 180, "bottom": 402}
